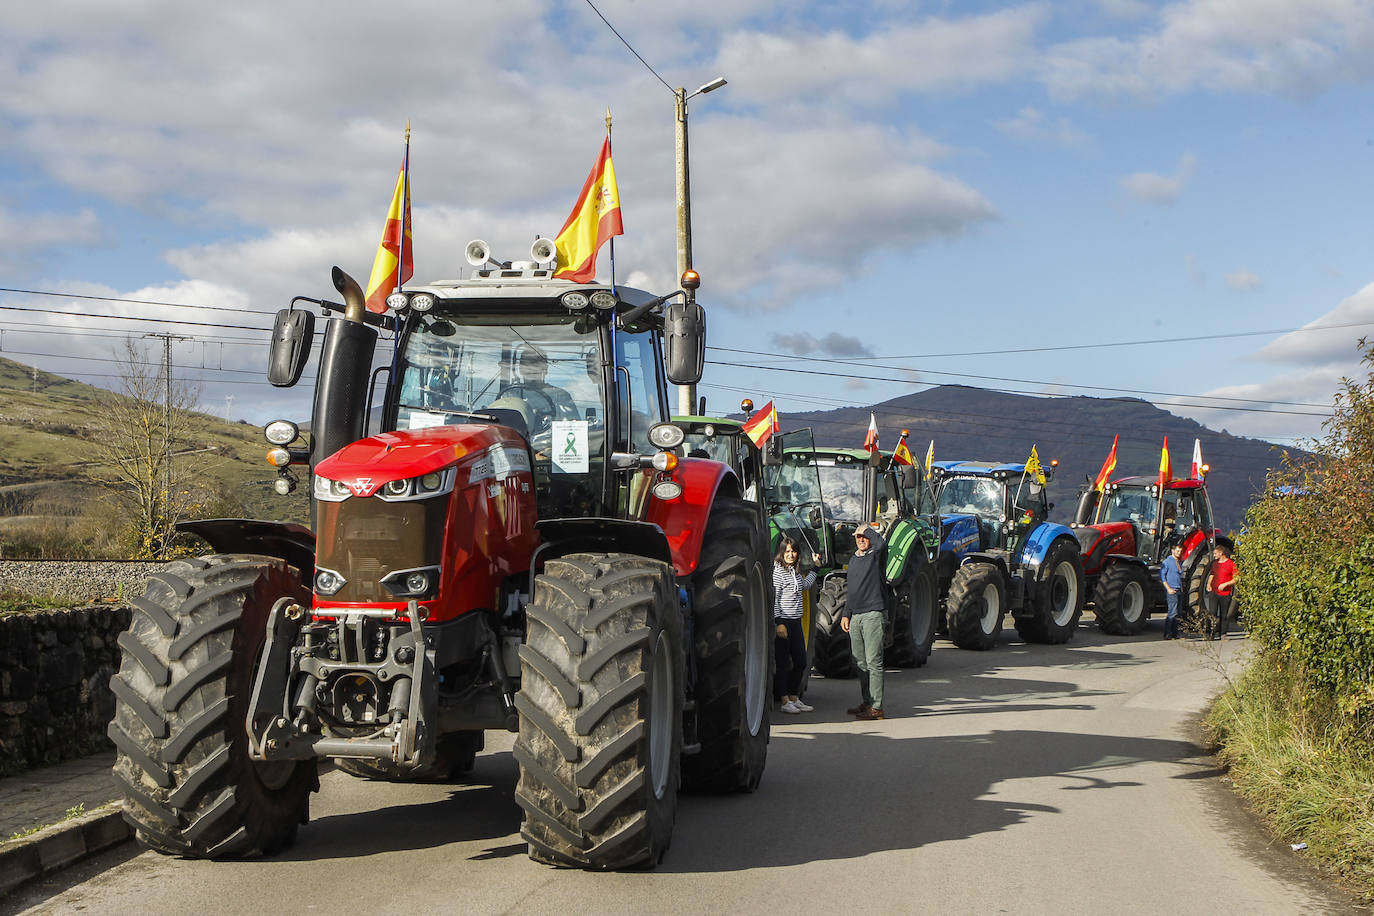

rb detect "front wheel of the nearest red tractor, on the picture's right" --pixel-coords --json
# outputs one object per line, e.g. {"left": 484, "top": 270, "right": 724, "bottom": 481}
{"left": 514, "top": 553, "right": 686, "bottom": 869}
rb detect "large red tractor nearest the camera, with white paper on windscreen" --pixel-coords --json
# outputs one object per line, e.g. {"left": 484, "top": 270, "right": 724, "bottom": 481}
{"left": 110, "top": 240, "right": 772, "bottom": 869}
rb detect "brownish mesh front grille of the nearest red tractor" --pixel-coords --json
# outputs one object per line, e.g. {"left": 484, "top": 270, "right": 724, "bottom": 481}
{"left": 316, "top": 493, "right": 449, "bottom": 603}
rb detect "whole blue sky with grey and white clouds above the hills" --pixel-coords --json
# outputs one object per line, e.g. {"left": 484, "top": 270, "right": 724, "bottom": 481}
{"left": 0, "top": 0, "right": 1374, "bottom": 457}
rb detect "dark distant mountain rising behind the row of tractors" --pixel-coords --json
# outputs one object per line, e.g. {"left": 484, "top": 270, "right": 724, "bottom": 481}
{"left": 780, "top": 385, "right": 1293, "bottom": 529}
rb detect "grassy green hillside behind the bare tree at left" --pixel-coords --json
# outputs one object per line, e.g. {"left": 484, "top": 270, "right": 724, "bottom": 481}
{"left": 0, "top": 358, "right": 308, "bottom": 554}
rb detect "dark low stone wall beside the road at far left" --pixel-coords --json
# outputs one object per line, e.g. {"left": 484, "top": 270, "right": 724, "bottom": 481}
{"left": 0, "top": 609, "right": 129, "bottom": 773}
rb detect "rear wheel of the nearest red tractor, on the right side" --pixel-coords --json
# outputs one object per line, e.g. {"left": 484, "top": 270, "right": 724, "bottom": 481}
{"left": 683, "top": 499, "right": 774, "bottom": 792}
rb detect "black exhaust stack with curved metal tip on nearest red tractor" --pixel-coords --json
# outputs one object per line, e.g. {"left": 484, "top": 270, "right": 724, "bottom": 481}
{"left": 311, "top": 268, "right": 376, "bottom": 472}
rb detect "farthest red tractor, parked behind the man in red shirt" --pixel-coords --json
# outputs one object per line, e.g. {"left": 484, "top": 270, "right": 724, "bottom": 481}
{"left": 1072, "top": 467, "right": 1231, "bottom": 636}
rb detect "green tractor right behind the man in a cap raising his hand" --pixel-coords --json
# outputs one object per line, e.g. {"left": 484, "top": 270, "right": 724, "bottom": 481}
{"left": 782, "top": 442, "right": 940, "bottom": 677}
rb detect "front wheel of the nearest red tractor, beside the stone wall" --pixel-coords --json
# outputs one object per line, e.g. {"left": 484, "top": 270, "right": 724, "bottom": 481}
{"left": 109, "top": 555, "right": 320, "bottom": 858}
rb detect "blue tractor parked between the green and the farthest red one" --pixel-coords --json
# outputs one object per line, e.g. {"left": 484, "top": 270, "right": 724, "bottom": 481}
{"left": 930, "top": 461, "right": 1085, "bottom": 650}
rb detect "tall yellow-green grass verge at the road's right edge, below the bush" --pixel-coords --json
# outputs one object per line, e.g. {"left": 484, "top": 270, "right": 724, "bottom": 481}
{"left": 1208, "top": 654, "right": 1374, "bottom": 902}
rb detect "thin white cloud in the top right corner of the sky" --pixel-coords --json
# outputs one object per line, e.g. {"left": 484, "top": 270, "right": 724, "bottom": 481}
{"left": 1043, "top": 0, "right": 1374, "bottom": 99}
